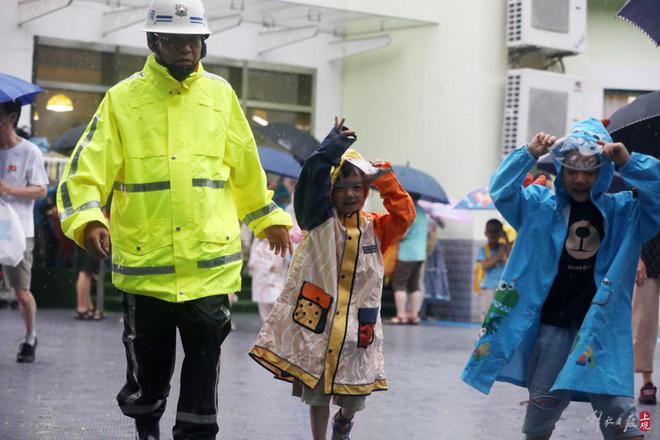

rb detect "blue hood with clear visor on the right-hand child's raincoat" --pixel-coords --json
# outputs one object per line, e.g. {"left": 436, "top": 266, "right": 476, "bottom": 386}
{"left": 551, "top": 118, "right": 614, "bottom": 201}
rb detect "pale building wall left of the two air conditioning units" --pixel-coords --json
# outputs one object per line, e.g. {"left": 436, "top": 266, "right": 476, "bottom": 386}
{"left": 343, "top": 0, "right": 506, "bottom": 238}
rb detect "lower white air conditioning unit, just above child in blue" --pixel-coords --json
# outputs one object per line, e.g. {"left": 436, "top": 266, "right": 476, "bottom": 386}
{"left": 502, "top": 69, "right": 584, "bottom": 156}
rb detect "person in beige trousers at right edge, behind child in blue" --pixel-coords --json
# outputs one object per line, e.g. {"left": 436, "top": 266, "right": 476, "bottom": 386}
{"left": 633, "top": 233, "right": 660, "bottom": 405}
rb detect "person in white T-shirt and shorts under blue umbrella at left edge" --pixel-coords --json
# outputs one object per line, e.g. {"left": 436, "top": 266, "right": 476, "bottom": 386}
{"left": 0, "top": 74, "right": 48, "bottom": 362}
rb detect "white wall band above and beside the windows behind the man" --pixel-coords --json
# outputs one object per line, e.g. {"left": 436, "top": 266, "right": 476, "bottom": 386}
{"left": 0, "top": 0, "right": 342, "bottom": 136}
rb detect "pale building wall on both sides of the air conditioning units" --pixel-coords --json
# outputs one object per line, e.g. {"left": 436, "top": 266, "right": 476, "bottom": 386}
{"left": 343, "top": 0, "right": 660, "bottom": 240}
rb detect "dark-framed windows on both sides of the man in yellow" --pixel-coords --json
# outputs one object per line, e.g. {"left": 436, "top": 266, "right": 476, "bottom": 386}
{"left": 32, "top": 37, "right": 314, "bottom": 148}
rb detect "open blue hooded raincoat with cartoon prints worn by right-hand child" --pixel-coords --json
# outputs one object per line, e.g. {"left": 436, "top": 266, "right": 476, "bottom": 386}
{"left": 462, "top": 118, "right": 660, "bottom": 400}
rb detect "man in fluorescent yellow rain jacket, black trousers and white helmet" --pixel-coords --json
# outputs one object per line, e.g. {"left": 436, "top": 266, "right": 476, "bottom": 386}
{"left": 57, "top": 0, "right": 291, "bottom": 439}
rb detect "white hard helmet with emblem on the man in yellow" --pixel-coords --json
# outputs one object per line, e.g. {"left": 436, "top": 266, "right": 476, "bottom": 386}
{"left": 142, "top": 0, "right": 211, "bottom": 35}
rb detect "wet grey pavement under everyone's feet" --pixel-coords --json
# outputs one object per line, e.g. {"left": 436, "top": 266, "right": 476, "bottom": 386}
{"left": 0, "top": 310, "right": 660, "bottom": 440}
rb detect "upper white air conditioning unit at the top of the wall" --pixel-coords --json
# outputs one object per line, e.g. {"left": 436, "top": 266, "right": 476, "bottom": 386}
{"left": 507, "top": 0, "right": 587, "bottom": 55}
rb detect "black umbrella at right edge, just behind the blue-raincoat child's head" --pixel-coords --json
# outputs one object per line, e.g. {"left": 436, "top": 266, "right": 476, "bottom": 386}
{"left": 607, "top": 90, "right": 660, "bottom": 157}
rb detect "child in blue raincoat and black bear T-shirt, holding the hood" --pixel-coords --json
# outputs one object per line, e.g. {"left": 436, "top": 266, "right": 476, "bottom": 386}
{"left": 462, "top": 118, "right": 660, "bottom": 439}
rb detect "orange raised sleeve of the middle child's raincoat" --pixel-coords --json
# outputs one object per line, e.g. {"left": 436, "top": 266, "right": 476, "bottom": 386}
{"left": 371, "top": 172, "right": 415, "bottom": 253}
